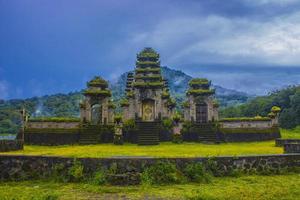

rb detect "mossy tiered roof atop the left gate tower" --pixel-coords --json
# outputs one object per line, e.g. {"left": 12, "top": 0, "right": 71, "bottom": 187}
{"left": 83, "top": 76, "right": 111, "bottom": 97}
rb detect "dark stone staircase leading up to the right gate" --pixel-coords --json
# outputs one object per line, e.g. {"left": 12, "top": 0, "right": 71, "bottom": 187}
{"left": 195, "top": 123, "right": 219, "bottom": 143}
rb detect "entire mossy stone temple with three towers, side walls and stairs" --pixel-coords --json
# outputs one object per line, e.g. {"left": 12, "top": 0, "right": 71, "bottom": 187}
{"left": 24, "top": 48, "right": 280, "bottom": 145}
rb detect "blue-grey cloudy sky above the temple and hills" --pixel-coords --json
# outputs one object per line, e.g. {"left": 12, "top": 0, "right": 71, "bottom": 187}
{"left": 0, "top": 0, "right": 300, "bottom": 99}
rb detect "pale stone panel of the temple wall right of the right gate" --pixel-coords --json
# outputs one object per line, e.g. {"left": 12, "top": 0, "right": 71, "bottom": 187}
{"left": 220, "top": 120, "right": 272, "bottom": 128}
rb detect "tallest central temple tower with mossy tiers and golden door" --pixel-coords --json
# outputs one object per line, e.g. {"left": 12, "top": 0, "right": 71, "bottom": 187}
{"left": 122, "top": 48, "right": 176, "bottom": 122}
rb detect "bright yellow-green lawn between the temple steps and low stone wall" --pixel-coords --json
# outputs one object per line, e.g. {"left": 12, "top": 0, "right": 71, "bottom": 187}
{"left": 2, "top": 141, "right": 283, "bottom": 158}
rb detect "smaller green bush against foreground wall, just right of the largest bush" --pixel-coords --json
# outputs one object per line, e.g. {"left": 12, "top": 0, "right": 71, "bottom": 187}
{"left": 183, "top": 163, "right": 212, "bottom": 183}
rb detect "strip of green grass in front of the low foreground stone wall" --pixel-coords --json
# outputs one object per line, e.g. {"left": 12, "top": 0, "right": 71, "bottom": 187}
{"left": 0, "top": 174, "right": 300, "bottom": 200}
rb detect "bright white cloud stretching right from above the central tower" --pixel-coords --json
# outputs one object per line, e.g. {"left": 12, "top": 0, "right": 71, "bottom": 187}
{"left": 122, "top": 12, "right": 300, "bottom": 66}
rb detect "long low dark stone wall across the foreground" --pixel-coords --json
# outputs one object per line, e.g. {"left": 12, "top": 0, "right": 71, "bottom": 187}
{"left": 0, "top": 154, "right": 300, "bottom": 180}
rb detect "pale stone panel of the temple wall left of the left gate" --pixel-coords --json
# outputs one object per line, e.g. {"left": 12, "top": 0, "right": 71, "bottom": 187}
{"left": 26, "top": 121, "right": 79, "bottom": 129}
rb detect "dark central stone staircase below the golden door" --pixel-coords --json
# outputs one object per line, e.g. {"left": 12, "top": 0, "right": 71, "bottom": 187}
{"left": 137, "top": 122, "right": 159, "bottom": 145}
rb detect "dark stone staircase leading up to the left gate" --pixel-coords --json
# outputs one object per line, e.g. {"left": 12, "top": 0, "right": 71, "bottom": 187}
{"left": 79, "top": 125, "right": 100, "bottom": 144}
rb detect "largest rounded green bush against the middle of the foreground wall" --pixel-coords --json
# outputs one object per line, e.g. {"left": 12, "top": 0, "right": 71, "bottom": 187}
{"left": 142, "top": 161, "right": 184, "bottom": 185}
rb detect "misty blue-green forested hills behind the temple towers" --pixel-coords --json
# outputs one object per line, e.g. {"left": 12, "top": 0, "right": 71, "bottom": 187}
{"left": 0, "top": 67, "right": 249, "bottom": 132}
